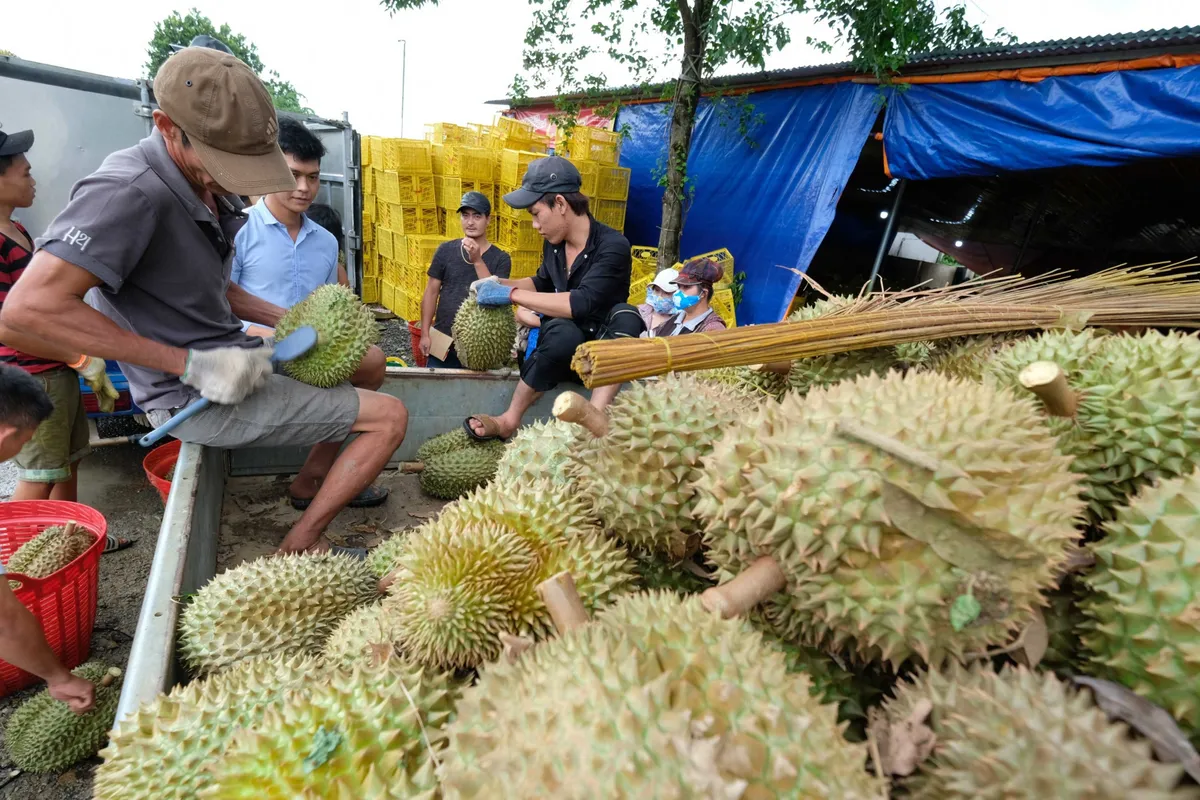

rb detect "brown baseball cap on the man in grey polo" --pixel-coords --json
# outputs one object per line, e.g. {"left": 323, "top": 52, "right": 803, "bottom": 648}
{"left": 154, "top": 47, "right": 296, "bottom": 194}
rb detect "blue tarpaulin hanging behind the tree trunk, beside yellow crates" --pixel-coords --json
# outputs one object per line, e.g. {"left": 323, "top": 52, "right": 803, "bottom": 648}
{"left": 617, "top": 83, "right": 880, "bottom": 325}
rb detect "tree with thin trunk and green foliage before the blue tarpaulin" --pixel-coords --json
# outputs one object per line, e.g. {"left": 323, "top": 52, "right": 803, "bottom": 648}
{"left": 380, "top": 0, "right": 1003, "bottom": 267}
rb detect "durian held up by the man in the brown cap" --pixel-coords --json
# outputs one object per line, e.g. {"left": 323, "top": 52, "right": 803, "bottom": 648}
{"left": 275, "top": 283, "right": 379, "bottom": 387}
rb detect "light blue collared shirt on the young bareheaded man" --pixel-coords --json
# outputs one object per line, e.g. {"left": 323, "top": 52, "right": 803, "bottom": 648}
{"left": 229, "top": 198, "right": 337, "bottom": 329}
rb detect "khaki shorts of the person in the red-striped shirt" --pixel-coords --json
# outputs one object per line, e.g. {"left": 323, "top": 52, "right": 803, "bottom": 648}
{"left": 13, "top": 367, "right": 91, "bottom": 483}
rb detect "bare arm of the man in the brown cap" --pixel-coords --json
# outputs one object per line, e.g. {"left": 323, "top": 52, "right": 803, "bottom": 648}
{"left": 0, "top": 249, "right": 187, "bottom": 375}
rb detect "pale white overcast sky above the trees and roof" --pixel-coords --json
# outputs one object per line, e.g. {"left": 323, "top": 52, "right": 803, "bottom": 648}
{"left": 0, "top": 0, "right": 1200, "bottom": 137}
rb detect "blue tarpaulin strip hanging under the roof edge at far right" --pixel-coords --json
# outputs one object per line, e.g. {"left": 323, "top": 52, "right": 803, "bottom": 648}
{"left": 883, "top": 66, "right": 1200, "bottom": 179}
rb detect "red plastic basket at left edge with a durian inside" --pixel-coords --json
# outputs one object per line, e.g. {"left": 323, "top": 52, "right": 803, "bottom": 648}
{"left": 0, "top": 500, "right": 108, "bottom": 697}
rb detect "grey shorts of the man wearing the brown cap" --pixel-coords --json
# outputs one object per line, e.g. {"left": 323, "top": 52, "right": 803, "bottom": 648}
{"left": 157, "top": 374, "right": 359, "bottom": 447}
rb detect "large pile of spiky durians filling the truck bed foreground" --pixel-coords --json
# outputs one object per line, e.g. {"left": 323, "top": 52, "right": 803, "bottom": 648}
{"left": 72, "top": 297, "right": 1200, "bottom": 800}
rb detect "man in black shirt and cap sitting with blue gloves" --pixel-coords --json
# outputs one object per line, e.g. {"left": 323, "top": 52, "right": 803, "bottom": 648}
{"left": 463, "top": 156, "right": 644, "bottom": 439}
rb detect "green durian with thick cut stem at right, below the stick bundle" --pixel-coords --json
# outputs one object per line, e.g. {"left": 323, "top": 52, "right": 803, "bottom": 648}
{"left": 986, "top": 329, "right": 1200, "bottom": 522}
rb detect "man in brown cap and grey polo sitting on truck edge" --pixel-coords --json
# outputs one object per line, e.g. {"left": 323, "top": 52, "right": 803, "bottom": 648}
{"left": 0, "top": 47, "right": 408, "bottom": 551}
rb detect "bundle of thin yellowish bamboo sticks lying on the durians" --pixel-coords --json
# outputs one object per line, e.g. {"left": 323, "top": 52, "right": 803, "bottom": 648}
{"left": 571, "top": 261, "right": 1200, "bottom": 389}
